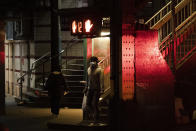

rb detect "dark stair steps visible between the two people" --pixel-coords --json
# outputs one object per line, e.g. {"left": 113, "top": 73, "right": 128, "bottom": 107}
{"left": 62, "top": 58, "right": 85, "bottom": 108}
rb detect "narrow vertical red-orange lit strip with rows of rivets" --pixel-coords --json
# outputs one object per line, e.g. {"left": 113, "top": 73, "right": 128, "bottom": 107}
{"left": 122, "top": 25, "right": 134, "bottom": 100}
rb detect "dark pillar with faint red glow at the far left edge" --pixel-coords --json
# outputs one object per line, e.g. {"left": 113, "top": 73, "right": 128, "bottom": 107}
{"left": 0, "top": 21, "right": 5, "bottom": 115}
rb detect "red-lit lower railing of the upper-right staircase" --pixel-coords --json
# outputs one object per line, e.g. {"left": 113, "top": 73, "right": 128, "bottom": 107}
{"left": 160, "top": 11, "right": 196, "bottom": 69}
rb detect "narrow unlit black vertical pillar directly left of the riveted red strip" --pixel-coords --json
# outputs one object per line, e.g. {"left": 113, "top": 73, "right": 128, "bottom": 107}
{"left": 109, "top": 0, "right": 122, "bottom": 131}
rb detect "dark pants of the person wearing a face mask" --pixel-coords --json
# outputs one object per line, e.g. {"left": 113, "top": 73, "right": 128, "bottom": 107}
{"left": 86, "top": 90, "right": 100, "bottom": 121}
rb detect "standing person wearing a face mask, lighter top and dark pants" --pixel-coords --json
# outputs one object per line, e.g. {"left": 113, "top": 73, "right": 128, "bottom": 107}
{"left": 86, "top": 56, "right": 104, "bottom": 123}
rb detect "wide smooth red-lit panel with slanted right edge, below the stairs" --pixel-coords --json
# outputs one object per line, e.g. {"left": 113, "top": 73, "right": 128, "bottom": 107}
{"left": 135, "top": 30, "right": 174, "bottom": 103}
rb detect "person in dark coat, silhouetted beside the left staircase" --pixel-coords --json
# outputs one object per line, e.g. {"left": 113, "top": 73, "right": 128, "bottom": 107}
{"left": 46, "top": 67, "right": 68, "bottom": 116}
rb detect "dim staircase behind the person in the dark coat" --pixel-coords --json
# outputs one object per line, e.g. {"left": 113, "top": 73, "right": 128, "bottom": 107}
{"left": 15, "top": 39, "right": 84, "bottom": 108}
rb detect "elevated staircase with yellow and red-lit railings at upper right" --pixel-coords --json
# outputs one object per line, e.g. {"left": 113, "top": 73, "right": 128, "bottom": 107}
{"left": 145, "top": 0, "right": 196, "bottom": 70}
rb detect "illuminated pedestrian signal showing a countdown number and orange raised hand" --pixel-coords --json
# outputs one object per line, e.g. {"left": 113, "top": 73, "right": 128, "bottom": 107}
{"left": 71, "top": 18, "right": 101, "bottom": 37}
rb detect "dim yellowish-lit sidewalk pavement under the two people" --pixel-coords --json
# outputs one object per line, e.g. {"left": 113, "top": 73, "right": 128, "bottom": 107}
{"left": 0, "top": 95, "right": 196, "bottom": 131}
